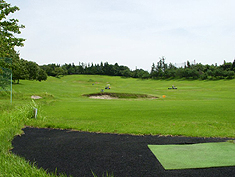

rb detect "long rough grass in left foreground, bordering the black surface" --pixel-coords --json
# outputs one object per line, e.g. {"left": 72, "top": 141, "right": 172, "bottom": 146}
{"left": 0, "top": 103, "right": 67, "bottom": 177}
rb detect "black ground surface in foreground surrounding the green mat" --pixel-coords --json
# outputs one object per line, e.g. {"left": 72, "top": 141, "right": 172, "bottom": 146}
{"left": 12, "top": 127, "right": 235, "bottom": 177}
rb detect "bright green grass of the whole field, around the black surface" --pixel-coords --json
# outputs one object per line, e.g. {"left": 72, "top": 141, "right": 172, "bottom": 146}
{"left": 0, "top": 75, "right": 235, "bottom": 176}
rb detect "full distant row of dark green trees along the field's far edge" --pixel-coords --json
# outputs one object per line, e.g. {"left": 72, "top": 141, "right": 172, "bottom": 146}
{"left": 40, "top": 57, "right": 235, "bottom": 80}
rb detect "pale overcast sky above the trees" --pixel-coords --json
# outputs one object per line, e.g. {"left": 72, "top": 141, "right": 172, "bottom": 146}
{"left": 7, "top": 0, "right": 235, "bottom": 70}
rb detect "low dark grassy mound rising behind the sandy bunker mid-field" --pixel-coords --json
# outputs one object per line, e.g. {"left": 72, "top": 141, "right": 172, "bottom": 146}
{"left": 83, "top": 92, "right": 158, "bottom": 98}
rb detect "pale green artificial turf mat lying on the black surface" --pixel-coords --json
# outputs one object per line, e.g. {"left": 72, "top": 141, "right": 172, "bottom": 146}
{"left": 148, "top": 142, "right": 235, "bottom": 170}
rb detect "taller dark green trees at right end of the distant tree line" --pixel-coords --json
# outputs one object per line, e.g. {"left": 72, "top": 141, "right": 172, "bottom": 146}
{"left": 150, "top": 57, "right": 235, "bottom": 80}
